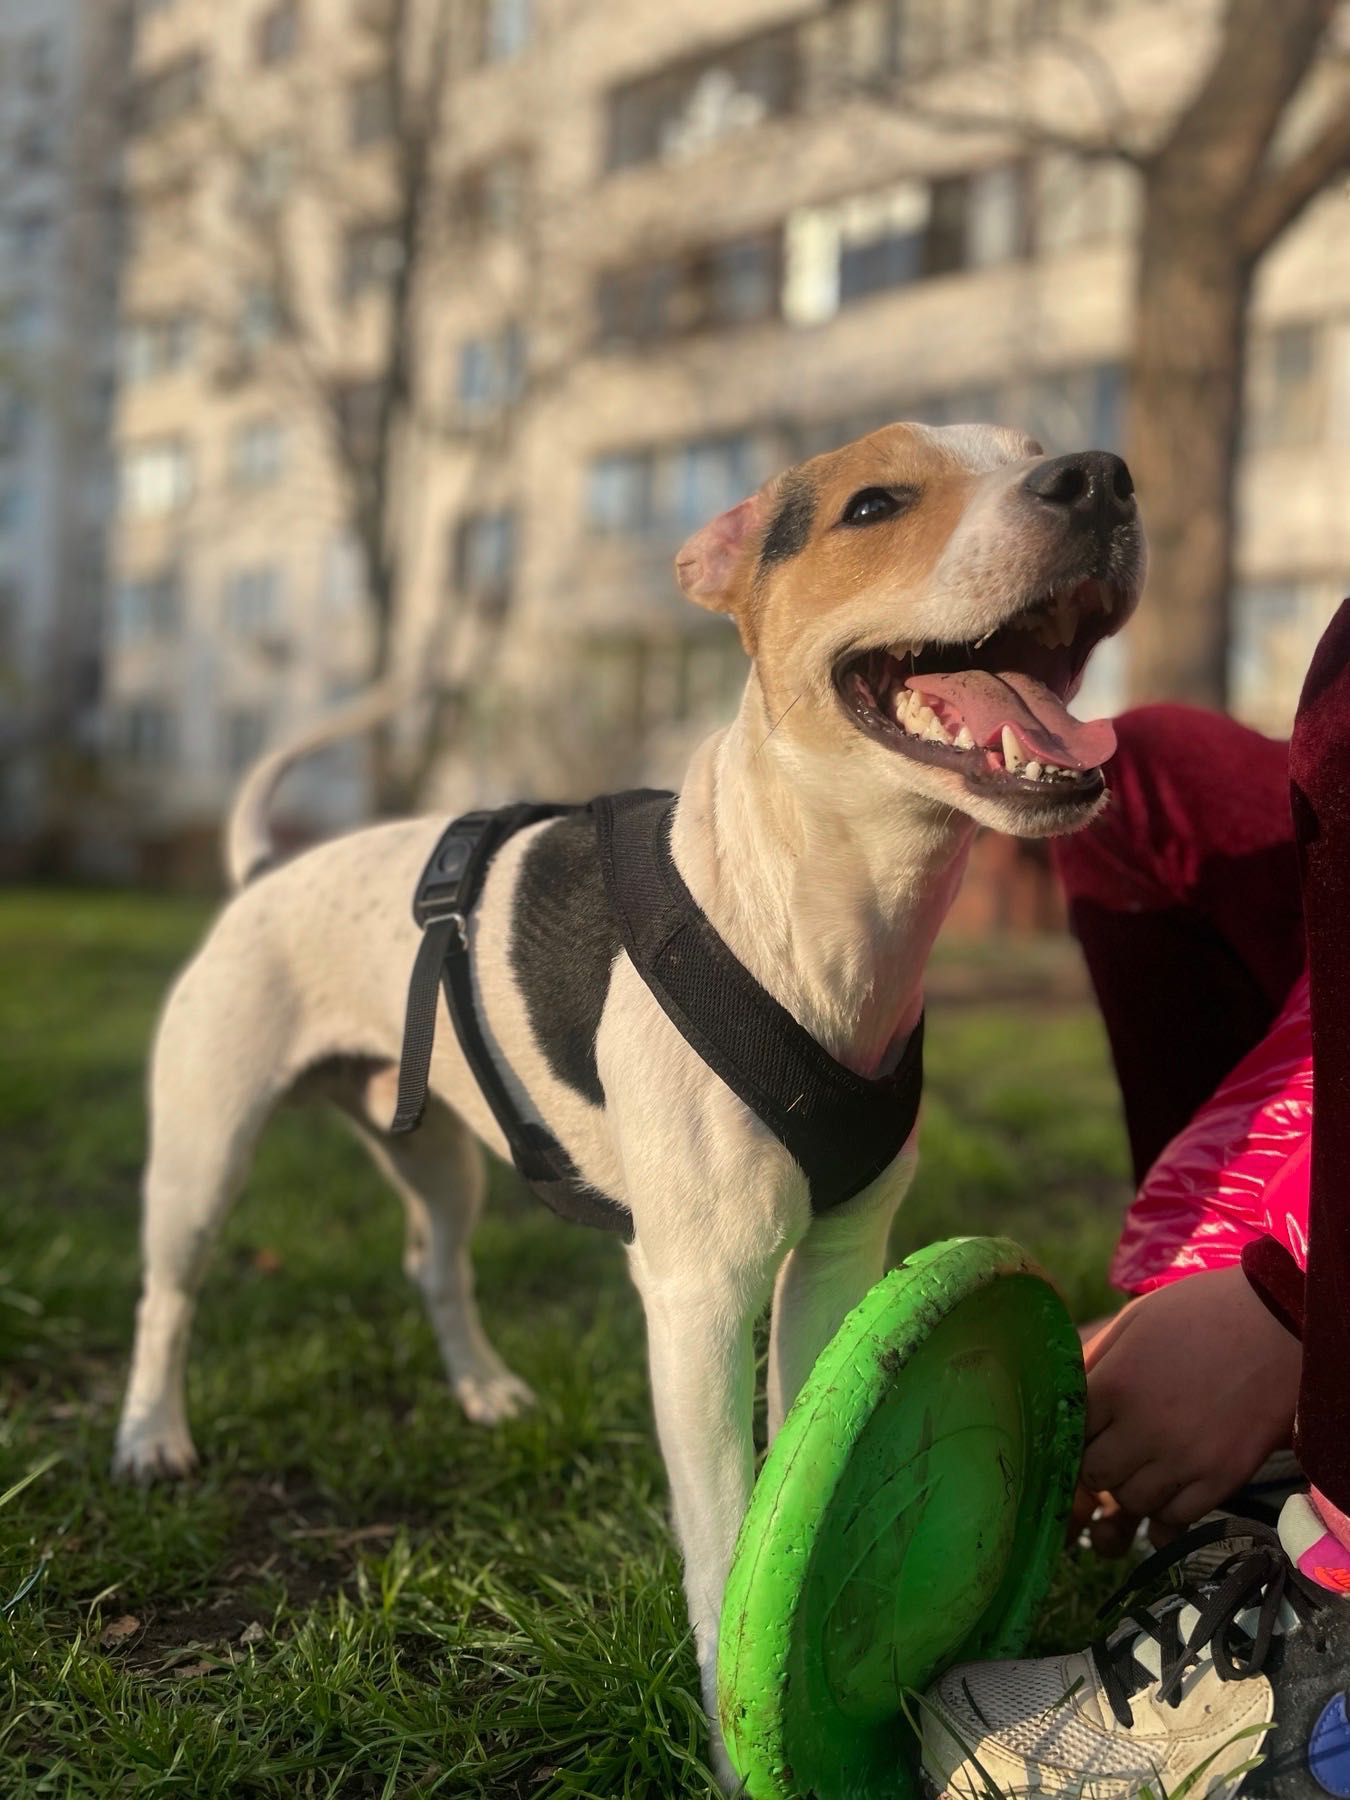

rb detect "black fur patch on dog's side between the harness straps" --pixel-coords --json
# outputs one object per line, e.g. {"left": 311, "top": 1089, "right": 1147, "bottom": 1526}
{"left": 511, "top": 812, "right": 619, "bottom": 1107}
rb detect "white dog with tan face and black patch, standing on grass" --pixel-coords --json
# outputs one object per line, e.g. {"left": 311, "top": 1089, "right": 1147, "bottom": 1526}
{"left": 115, "top": 425, "right": 1147, "bottom": 1778}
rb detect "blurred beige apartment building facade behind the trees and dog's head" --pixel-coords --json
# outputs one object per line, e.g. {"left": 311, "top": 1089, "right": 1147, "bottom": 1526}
{"left": 104, "top": 0, "right": 1350, "bottom": 871}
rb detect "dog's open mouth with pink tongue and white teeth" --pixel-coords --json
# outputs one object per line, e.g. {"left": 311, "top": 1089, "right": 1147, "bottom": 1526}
{"left": 835, "top": 580, "right": 1121, "bottom": 803}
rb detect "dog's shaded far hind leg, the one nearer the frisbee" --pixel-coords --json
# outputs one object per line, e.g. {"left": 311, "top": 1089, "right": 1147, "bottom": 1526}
{"left": 344, "top": 1069, "right": 535, "bottom": 1426}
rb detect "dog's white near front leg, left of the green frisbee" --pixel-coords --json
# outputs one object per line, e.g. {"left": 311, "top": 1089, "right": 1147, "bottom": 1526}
{"left": 632, "top": 1249, "right": 765, "bottom": 1786}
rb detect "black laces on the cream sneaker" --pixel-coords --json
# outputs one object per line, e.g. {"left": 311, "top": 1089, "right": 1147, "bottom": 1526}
{"left": 1091, "top": 1519, "right": 1327, "bottom": 1730}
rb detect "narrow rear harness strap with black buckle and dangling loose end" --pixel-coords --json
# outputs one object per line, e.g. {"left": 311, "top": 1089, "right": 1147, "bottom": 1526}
{"left": 389, "top": 805, "right": 634, "bottom": 1242}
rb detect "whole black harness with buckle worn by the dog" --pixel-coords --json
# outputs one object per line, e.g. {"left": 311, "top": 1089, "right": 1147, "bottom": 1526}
{"left": 391, "top": 788, "right": 923, "bottom": 1242}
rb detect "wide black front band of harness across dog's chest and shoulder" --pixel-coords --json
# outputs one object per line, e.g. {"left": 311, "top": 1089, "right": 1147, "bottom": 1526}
{"left": 594, "top": 792, "right": 923, "bottom": 1213}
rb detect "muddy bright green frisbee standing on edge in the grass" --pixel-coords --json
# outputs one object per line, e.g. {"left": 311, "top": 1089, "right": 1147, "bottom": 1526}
{"left": 718, "top": 1238, "right": 1084, "bottom": 1800}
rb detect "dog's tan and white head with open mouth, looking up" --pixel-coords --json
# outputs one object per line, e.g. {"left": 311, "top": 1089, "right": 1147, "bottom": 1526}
{"left": 675, "top": 425, "right": 1145, "bottom": 837}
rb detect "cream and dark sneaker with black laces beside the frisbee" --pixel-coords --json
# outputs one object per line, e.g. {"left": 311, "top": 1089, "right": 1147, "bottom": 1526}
{"left": 920, "top": 1519, "right": 1350, "bottom": 1800}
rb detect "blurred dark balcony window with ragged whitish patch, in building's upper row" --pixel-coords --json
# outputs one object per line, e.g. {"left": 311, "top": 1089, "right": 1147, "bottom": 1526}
{"left": 605, "top": 31, "right": 797, "bottom": 169}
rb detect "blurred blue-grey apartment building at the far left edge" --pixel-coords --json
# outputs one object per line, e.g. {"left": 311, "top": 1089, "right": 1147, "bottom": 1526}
{"left": 0, "top": 0, "right": 126, "bottom": 868}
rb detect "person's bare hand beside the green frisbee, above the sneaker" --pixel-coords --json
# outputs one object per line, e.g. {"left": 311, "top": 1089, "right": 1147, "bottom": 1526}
{"left": 1082, "top": 1269, "right": 1301, "bottom": 1553}
